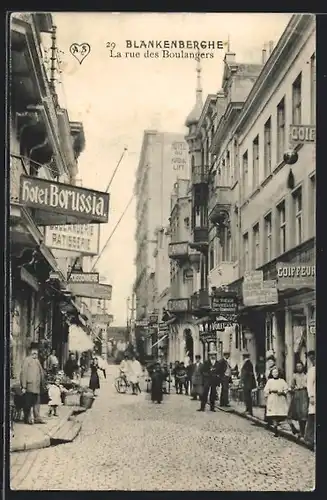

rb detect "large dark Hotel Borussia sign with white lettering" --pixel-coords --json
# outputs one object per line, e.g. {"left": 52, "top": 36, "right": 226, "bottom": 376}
{"left": 19, "top": 175, "right": 109, "bottom": 226}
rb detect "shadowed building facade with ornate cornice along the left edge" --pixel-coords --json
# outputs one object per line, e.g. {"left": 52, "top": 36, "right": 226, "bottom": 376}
{"left": 8, "top": 13, "right": 89, "bottom": 378}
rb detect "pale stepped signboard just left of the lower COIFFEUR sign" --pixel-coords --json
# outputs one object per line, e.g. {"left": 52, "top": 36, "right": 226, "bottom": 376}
{"left": 242, "top": 271, "right": 278, "bottom": 307}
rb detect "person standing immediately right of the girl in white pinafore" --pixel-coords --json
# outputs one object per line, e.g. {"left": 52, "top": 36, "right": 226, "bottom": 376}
{"left": 288, "top": 361, "right": 309, "bottom": 438}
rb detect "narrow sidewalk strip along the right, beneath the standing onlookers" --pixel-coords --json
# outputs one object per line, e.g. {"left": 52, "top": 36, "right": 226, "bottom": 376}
{"left": 217, "top": 401, "right": 311, "bottom": 449}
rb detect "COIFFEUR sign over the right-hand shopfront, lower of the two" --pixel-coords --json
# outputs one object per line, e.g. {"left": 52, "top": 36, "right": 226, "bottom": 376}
{"left": 276, "top": 262, "right": 316, "bottom": 290}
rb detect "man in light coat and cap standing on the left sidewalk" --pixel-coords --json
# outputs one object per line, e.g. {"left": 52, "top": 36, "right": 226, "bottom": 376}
{"left": 20, "top": 342, "right": 45, "bottom": 425}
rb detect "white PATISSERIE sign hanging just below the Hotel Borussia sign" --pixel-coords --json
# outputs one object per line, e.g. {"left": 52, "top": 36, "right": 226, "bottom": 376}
{"left": 44, "top": 224, "right": 100, "bottom": 255}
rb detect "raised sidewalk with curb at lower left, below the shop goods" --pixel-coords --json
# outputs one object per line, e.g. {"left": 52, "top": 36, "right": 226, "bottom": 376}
{"left": 10, "top": 376, "right": 89, "bottom": 452}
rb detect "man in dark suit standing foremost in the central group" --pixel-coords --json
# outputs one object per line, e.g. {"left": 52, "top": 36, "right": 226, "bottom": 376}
{"left": 197, "top": 351, "right": 223, "bottom": 411}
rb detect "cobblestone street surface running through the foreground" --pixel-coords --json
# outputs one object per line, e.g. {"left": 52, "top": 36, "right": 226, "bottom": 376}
{"left": 11, "top": 366, "right": 315, "bottom": 491}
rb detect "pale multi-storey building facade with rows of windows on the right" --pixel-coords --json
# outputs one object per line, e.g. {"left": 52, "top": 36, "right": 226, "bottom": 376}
{"left": 208, "top": 14, "right": 316, "bottom": 381}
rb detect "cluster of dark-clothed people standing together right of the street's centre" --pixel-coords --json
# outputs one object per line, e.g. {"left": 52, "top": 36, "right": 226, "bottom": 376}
{"left": 172, "top": 351, "right": 231, "bottom": 411}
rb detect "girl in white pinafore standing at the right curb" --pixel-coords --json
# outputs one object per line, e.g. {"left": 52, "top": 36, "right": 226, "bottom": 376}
{"left": 264, "top": 368, "right": 289, "bottom": 436}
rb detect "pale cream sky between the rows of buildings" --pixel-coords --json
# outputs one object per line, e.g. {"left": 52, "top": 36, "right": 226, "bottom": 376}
{"left": 44, "top": 12, "right": 291, "bottom": 326}
